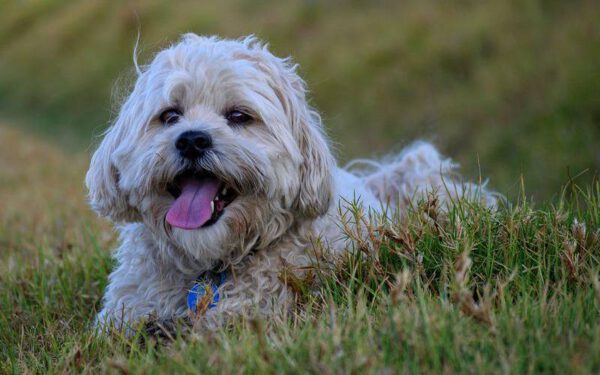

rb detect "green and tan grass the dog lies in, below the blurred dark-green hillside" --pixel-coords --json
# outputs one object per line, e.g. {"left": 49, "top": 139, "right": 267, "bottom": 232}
{"left": 0, "top": 127, "right": 600, "bottom": 374}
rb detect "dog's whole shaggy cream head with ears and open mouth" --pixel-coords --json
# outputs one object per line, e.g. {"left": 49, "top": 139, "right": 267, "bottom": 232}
{"left": 86, "top": 35, "right": 334, "bottom": 262}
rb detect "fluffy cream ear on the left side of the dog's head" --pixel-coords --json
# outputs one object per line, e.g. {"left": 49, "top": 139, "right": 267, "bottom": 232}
{"left": 85, "top": 125, "right": 139, "bottom": 222}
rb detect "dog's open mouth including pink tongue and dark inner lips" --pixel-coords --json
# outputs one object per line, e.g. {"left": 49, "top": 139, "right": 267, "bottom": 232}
{"left": 166, "top": 172, "right": 238, "bottom": 230}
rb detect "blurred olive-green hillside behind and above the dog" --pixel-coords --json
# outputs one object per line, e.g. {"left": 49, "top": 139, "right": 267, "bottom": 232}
{"left": 0, "top": 0, "right": 600, "bottom": 198}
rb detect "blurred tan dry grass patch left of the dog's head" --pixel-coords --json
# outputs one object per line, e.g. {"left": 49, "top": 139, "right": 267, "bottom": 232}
{"left": 0, "top": 124, "right": 112, "bottom": 266}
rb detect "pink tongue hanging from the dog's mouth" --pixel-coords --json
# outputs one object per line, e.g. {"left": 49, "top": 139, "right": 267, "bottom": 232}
{"left": 167, "top": 177, "right": 219, "bottom": 229}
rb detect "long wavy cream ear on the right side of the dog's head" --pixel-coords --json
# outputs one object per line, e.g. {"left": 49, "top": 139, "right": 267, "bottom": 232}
{"left": 264, "top": 54, "right": 335, "bottom": 218}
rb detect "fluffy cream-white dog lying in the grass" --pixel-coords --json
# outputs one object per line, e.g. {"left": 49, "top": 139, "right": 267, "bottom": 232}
{"left": 86, "top": 34, "right": 495, "bottom": 326}
